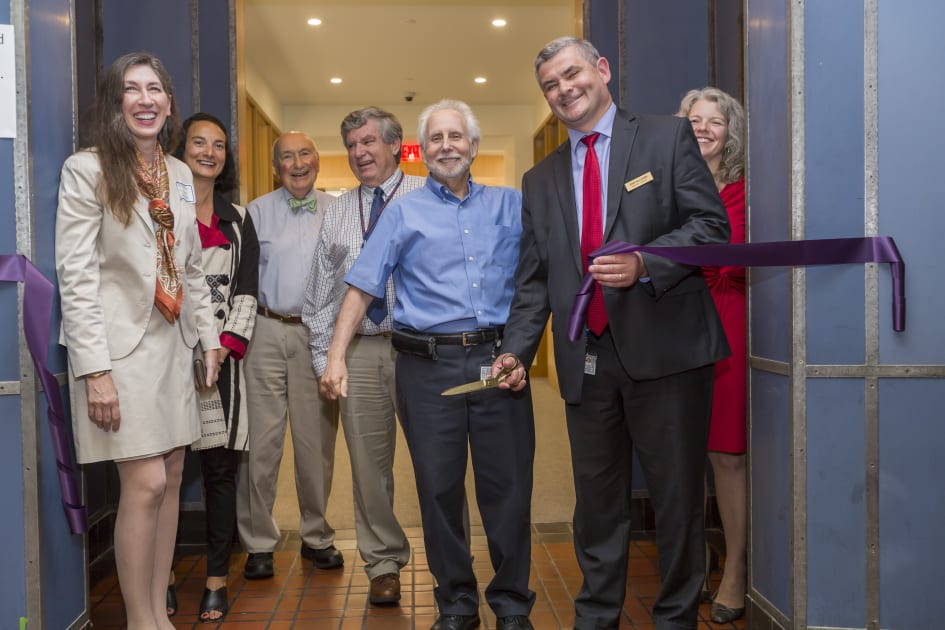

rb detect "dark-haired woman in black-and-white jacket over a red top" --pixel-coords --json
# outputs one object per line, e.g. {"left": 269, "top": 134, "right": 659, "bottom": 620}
{"left": 168, "top": 113, "right": 259, "bottom": 622}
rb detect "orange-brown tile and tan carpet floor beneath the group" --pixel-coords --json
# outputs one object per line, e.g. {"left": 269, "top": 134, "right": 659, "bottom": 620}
{"left": 90, "top": 378, "right": 745, "bottom": 630}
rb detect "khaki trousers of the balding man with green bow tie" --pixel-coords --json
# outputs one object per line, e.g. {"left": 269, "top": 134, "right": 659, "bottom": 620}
{"left": 236, "top": 315, "right": 338, "bottom": 553}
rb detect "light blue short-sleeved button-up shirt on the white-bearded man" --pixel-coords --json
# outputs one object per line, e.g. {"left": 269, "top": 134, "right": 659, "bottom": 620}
{"left": 345, "top": 177, "right": 522, "bottom": 333}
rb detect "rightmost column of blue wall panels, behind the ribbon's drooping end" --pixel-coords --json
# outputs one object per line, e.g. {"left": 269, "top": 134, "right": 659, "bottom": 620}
{"left": 879, "top": 0, "right": 945, "bottom": 628}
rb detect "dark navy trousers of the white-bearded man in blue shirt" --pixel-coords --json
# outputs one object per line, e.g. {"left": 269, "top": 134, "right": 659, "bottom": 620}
{"left": 396, "top": 344, "right": 535, "bottom": 617}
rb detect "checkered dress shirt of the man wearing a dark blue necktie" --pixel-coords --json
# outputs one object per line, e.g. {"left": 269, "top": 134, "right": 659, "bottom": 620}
{"left": 302, "top": 169, "right": 426, "bottom": 376}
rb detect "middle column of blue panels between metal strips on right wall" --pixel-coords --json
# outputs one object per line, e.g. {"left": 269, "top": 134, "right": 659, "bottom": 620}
{"left": 803, "top": 0, "right": 866, "bottom": 627}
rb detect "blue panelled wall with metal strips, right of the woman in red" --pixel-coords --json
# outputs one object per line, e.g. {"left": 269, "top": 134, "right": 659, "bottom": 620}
{"left": 747, "top": 0, "right": 945, "bottom": 628}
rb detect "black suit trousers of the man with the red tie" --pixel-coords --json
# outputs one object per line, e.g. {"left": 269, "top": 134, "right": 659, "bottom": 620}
{"left": 566, "top": 330, "right": 713, "bottom": 630}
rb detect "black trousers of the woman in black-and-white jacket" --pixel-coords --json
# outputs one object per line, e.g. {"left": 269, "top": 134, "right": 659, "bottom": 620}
{"left": 197, "top": 446, "right": 240, "bottom": 577}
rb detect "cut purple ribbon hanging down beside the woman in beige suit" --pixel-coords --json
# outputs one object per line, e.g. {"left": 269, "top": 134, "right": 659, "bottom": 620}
{"left": 0, "top": 254, "right": 89, "bottom": 534}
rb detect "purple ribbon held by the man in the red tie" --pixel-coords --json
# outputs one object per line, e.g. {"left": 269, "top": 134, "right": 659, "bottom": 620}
{"left": 568, "top": 236, "right": 906, "bottom": 341}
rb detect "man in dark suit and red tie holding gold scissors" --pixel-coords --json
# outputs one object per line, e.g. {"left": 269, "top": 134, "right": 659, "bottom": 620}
{"left": 493, "top": 37, "right": 729, "bottom": 630}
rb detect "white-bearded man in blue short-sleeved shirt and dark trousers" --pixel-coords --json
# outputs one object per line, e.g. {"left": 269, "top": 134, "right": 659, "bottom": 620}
{"left": 321, "top": 100, "right": 535, "bottom": 630}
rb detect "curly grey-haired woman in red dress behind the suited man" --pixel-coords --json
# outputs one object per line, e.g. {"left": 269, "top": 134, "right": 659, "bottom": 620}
{"left": 678, "top": 87, "right": 748, "bottom": 623}
